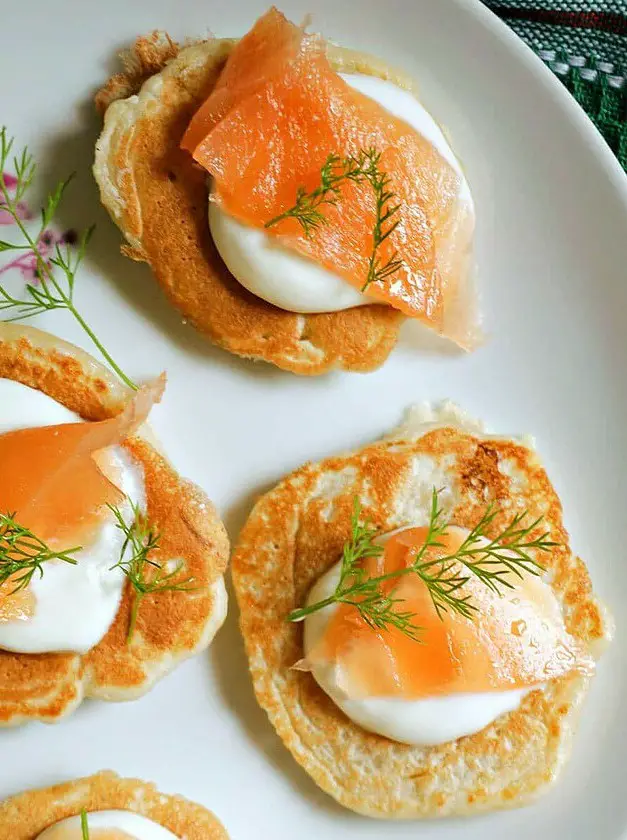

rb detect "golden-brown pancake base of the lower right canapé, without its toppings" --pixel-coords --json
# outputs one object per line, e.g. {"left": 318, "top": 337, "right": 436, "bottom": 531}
{"left": 232, "top": 407, "right": 610, "bottom": 818}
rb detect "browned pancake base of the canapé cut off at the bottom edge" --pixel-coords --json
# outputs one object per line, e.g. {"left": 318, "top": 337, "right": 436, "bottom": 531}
{"left": 0, "top": 771, "right": 228, "bottom": 840}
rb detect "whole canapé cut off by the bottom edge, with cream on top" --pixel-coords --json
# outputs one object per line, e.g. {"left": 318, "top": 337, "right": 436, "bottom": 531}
{"left": 0, "top": 771, "right": 228, "bottom": 840}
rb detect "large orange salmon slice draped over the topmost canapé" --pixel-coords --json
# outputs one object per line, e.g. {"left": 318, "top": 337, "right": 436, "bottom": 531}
{"left": 183, "top": 9, "right": 474, "bottom": 347}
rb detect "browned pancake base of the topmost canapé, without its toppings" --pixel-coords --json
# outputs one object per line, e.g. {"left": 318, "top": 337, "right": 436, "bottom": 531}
{"left": 94, "top": 32, "right": 412, "bottom": 376}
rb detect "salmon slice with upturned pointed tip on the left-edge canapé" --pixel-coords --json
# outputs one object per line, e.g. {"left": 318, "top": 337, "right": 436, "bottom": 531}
{"left": 0, "top": 375, "right": 165, "bottom": 550}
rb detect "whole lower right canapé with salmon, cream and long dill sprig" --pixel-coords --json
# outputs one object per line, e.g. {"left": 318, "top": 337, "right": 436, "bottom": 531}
{"left": 233, "top": 406, "right": 610, "bottom": 818}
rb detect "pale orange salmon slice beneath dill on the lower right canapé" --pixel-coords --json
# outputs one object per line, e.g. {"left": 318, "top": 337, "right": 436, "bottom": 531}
{"left": 306, "top": 528, "right": 594, "bottom": 700}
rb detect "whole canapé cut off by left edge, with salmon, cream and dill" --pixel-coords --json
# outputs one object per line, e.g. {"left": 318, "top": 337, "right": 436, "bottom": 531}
{"left": 0, "top": 324, "right": 228, "bottom": 725}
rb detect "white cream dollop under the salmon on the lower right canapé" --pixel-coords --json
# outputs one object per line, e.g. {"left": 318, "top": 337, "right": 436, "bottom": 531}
{"left": 304, "top": 556, "right": 528, "bottom": 747}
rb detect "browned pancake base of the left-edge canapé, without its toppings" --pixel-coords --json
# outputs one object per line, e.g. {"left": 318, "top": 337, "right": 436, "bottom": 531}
{"left": 0, "top": 323, "right": 229, "bottom": 726}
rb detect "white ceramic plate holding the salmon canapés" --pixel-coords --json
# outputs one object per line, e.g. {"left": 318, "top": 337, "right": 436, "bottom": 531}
{"left": 0, "top": 0, "right": 627, "bottom": 840}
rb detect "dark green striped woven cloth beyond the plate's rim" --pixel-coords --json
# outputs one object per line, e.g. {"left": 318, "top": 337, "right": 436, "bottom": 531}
{"left": 484, "top": 0, "right": 627, "bottom": 171}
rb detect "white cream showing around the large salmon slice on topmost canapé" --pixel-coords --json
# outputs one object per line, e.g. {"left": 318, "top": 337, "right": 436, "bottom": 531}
{"left": 209, "top": 74, "right": 472, "bottom": 313}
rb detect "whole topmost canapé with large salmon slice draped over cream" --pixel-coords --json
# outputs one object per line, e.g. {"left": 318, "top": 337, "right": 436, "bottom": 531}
{"left": 94, "top": 9, "right": 478, "bottom": 374}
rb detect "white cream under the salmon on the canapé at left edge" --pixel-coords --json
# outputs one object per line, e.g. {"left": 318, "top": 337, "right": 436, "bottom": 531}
{"left": 0, "top": 379, "right": 145, "bottom": 653}
